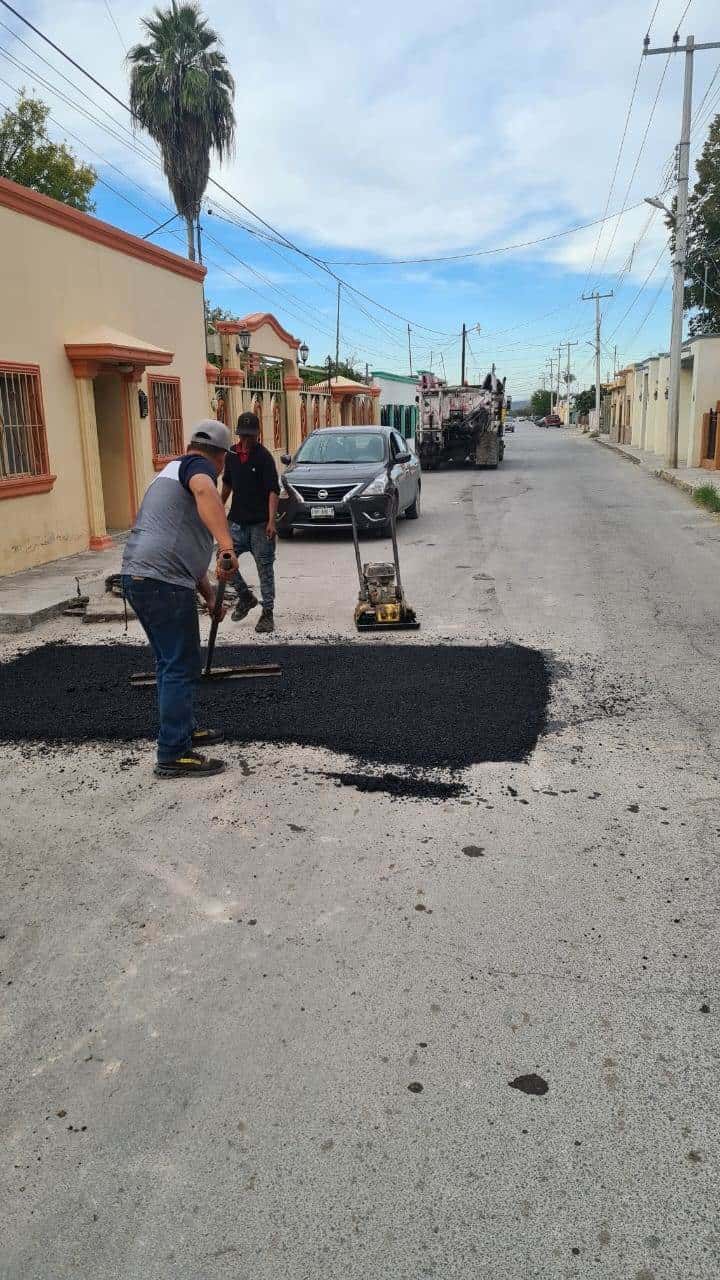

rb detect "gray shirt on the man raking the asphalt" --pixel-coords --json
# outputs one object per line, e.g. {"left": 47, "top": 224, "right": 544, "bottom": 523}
{"left": 123, "top": 458, "right": 213, "bottom": 589}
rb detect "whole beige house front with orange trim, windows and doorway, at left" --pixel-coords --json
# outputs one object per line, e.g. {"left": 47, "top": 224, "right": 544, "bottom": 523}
{"left": 0, "top": 179, "right": 208, "bottom": 573}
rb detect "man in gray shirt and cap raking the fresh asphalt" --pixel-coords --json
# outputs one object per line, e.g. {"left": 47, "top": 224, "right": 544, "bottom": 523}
{"left": 123, "top": 419, "right": 237, "bottom": 778}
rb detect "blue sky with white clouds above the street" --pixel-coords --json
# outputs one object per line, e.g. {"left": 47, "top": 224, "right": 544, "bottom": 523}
{"left": 0, "top": 0, "right": 720, "bottom": 398}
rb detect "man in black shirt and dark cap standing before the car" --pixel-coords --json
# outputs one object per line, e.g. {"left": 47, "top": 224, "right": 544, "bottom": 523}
{"left": 222, "top": 413, "right": 281, "bottom": 635}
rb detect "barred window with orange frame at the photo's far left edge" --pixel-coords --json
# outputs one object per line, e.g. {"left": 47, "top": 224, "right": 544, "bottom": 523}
{"left": 0, "top": 364, "right": 55, "bottom": 498}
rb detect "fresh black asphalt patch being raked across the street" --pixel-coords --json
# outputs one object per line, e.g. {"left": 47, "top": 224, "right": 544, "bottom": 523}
{"left": 0, "top": 644, "right": 551, "bottom": 768}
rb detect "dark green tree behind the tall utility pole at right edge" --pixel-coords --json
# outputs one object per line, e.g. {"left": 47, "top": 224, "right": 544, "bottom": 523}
{"left": 685, "top": 115, "right": 720, "bottom": 334}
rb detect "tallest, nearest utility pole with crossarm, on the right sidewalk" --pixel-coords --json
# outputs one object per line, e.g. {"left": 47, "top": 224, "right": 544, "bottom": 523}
{"left": 643, "top": 32, "right": 720, "bottom": 467}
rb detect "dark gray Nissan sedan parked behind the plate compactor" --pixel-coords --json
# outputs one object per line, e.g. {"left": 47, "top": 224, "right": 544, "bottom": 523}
{"left": 278, "top": 426, "right": 423, "bottom": 538}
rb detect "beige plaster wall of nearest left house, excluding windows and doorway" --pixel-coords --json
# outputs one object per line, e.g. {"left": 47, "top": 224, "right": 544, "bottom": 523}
{"left": 0, "top": 182, "right": 208, "bottom": 573}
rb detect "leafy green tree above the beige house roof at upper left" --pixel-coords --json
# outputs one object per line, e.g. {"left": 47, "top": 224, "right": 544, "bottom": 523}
{"left": 0, "top": 90, "right": 97, "bottom": 214}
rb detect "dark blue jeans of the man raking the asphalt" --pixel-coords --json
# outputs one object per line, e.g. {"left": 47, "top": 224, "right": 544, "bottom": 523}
{"left": 123, "top": 575, "right": 202, "bottom": 764}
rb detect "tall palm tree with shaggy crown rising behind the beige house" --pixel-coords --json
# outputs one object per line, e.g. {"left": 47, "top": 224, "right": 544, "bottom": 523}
{"left": 128, "top": 0, "right": 234, "bottom": 261}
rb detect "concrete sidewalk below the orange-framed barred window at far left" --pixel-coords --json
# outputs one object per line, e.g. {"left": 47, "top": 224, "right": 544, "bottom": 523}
{"left": 0, "top": 535, "right": 124, "bottom": 635}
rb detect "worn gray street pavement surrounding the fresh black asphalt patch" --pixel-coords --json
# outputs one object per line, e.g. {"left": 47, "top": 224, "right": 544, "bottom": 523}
{"left": 0, "top": 426, "right": 720, "bottom": 1280}
